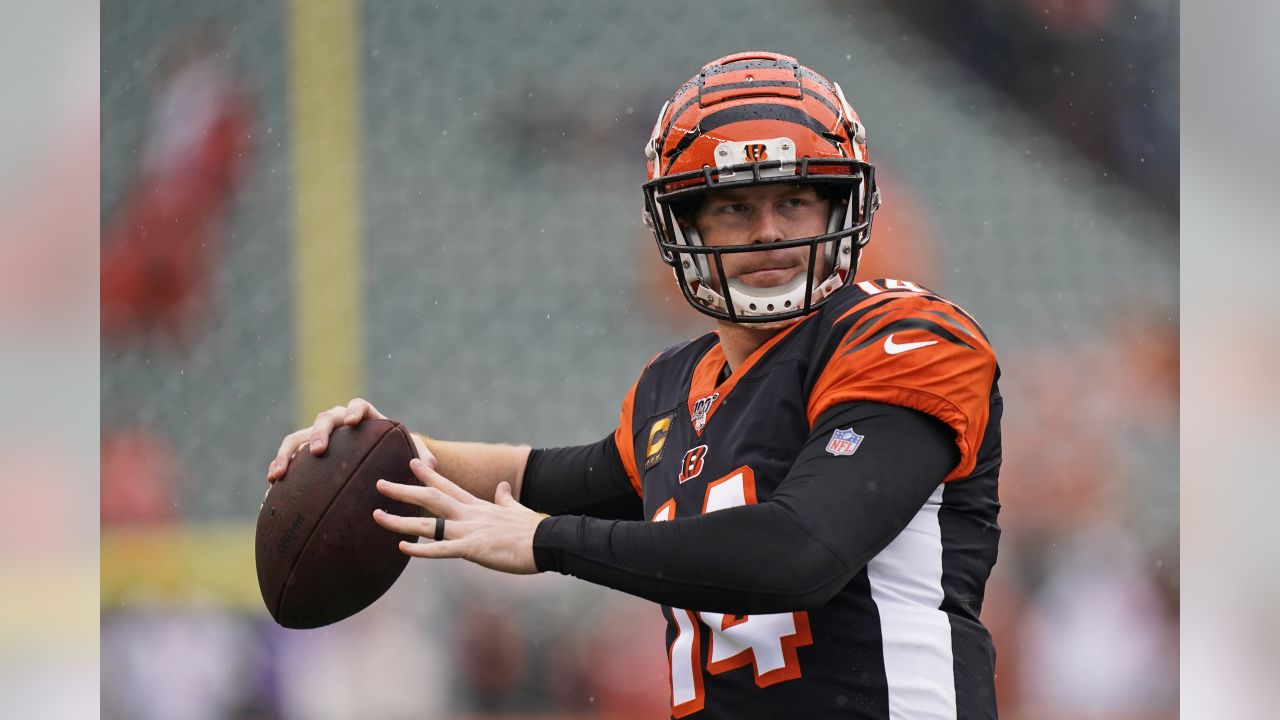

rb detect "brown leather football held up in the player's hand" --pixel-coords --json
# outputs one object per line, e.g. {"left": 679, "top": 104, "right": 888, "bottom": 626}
{"left": 255, "top": 419, "right": 421, "bottom": 628}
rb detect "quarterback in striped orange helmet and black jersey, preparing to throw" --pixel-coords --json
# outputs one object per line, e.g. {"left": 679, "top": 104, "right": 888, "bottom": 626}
{"left": 268, "top": 53, "right": 1002, "bottom": 719}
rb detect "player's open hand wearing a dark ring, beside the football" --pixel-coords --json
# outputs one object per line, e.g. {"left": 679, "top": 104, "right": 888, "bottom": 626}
{"left": 374, "top": 457, "right": 547, "bottom": 574}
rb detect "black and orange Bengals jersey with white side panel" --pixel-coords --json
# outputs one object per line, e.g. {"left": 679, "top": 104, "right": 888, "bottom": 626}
{"left": 614, "top": 281, "right": 1001, "bottom": 719}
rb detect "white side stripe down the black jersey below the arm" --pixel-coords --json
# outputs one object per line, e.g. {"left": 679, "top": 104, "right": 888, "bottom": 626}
{"left": 867, "top": 484, "right": 956, "bottom": 720}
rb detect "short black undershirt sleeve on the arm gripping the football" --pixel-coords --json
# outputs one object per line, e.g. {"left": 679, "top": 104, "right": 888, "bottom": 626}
{"left": 520, "top": 433, "right": 644, "bottom": 520}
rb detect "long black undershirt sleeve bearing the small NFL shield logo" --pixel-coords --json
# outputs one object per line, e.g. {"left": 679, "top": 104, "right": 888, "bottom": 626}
{"left": 534, "top": 402, "right": 959, "bottom": 614}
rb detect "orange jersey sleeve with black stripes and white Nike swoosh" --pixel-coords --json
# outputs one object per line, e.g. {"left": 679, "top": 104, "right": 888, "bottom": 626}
{"left": 808, "top": 293, "right": 996, "bottom": 480}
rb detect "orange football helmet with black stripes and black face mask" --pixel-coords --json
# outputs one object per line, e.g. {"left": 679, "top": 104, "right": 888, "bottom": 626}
{"left": 644, "top": 53, "right": 879, "bottom": 323}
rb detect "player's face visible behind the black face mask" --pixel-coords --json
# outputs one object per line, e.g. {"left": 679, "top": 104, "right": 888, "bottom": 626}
{"left": 694, "top": 184, "right": 831, "bottom": 291}
